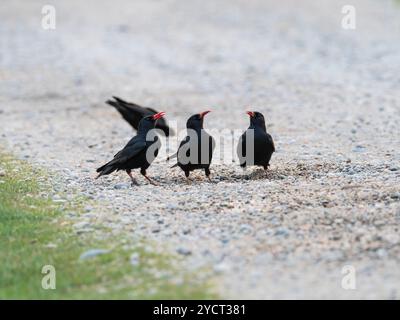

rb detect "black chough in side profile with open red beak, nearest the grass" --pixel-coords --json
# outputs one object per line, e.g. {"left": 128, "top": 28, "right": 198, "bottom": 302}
{"left": 96, "top": 112, "right": 165, "bottom": 186}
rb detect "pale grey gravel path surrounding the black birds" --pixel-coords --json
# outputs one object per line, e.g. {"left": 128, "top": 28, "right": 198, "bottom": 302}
{"left": 0, "top": 0, "right": 400, "bottom": 299}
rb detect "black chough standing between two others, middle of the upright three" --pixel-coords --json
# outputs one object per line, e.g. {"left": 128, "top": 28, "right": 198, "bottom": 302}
{"left": 167, "top": 111, "right": 215, "bottom": 181}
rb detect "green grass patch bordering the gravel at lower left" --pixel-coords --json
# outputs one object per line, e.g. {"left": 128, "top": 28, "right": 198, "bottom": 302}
{"left": 0, "top": 150, "right": 215, "bottom": 299}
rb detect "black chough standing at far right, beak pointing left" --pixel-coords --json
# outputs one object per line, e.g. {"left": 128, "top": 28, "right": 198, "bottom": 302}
{"left": 237, "top": 111, "right": 275, "bottom": 170}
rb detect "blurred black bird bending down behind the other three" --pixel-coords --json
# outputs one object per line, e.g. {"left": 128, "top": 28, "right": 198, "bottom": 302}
{"left": 106, "top": 97, "right": 174, "bottom": 137}
